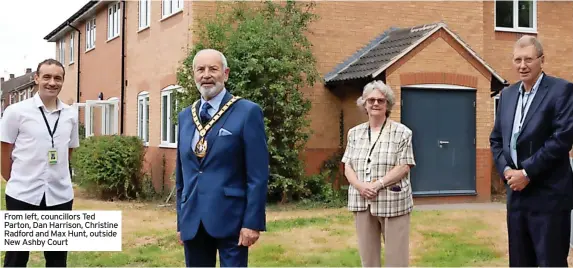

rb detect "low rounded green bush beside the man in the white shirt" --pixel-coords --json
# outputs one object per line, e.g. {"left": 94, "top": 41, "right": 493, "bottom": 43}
{"left": 72, "top": 135, "right": 145, "bottom": 199}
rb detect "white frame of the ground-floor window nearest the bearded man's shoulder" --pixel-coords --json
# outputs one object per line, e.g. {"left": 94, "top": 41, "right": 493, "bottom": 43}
{"left": 159, "top": 85, "right": 182, "bottom": 148}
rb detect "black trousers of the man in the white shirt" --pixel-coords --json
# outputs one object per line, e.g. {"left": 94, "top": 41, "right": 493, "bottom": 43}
{"left": 4, "top": 195, "right": 74, "bottom": 267}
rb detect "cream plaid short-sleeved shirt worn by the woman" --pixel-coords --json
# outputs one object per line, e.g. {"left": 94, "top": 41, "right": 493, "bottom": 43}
{"left": 342, "top": 119, "right": 416, "bottom": 217}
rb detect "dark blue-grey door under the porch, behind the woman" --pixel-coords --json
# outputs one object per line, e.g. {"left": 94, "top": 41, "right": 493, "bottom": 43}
{"left": 401, "top": 88, "right": 476, "bottom": 196}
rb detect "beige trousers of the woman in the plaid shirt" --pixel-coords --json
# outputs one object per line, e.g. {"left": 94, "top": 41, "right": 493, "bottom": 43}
{"left": 354, "top": 208, "right": 410, "bottom": 267}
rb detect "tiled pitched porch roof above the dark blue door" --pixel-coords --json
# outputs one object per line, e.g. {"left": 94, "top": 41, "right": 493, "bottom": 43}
{"left": 325, "top": 22, "right": 507, "bottom": 84}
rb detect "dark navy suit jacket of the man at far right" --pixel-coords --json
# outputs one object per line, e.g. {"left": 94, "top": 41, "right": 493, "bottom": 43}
{"left": 490, "top": 75, "right": 573, "bottom": 211}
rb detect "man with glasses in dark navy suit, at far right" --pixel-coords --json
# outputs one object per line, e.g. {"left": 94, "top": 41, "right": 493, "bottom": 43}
{"left": 490, "top": 36, "right": 573, "bottom": 267}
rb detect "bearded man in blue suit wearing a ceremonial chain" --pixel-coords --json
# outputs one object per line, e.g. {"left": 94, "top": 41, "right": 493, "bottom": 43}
{"left": 176, "top": 49, "right": 269, "bottom": 267}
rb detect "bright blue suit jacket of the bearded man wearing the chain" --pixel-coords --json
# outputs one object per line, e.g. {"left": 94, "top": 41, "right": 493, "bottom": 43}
{"left": 176, "top": 92, "right": 269, "bottom": 241}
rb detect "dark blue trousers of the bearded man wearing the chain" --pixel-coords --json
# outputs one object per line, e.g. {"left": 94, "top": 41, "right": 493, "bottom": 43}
{"left": 183, "top": 223, "right": 249, "bottom": 267}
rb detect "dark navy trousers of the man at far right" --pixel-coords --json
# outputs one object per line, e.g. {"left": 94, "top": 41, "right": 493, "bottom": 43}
{"left": 507, "top": 211, "right": 571, "bottom": 267}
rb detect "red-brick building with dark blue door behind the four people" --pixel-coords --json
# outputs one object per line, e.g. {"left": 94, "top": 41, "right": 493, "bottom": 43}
{"left": 45, "top": 0, "right": 573, "bottom": 201}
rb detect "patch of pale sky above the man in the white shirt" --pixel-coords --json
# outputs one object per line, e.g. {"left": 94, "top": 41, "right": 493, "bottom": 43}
{"left": 0, "top": 0, "right": 88, "bottom": 79}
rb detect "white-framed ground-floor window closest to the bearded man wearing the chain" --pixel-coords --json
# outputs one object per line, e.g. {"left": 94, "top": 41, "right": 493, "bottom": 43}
{"left": 161, "top": 86, "right": 181, "bottom": 147}
